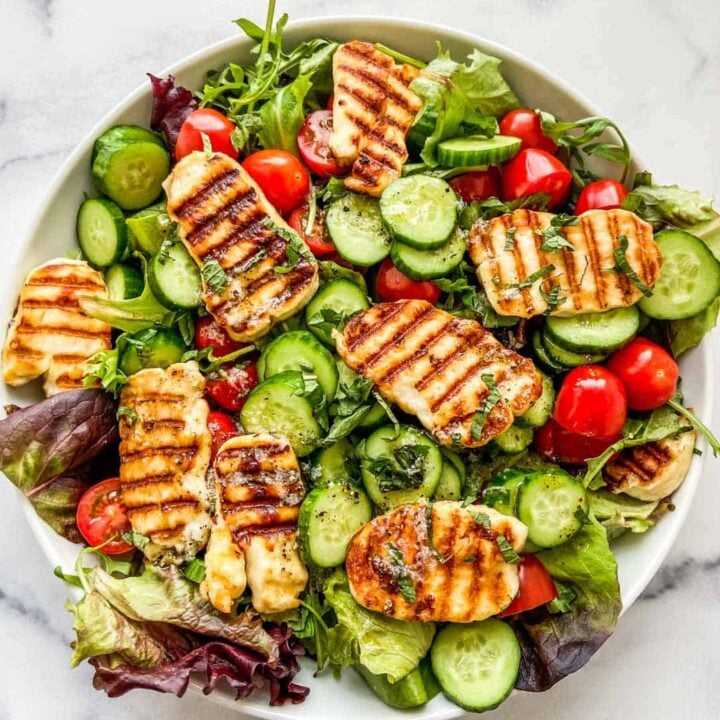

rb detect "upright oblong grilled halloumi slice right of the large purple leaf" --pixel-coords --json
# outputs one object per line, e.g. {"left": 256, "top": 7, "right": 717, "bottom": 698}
{"left": 120, "top": 362, "right": 212, "bottom": 564}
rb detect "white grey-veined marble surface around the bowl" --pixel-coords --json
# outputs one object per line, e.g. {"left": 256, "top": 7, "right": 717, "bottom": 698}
{"left": 0, "top": 0, "right": 720, "bottom": 720}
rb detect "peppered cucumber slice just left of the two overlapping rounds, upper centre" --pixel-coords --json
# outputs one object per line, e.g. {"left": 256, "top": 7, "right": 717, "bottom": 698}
{"left": 325, "top": 193, "right": 391, "bottom": 267}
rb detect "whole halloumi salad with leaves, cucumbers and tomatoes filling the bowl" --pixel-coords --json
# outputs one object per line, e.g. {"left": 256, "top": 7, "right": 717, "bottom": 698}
{"left": 0, "top": 3, "right": 720, "bottom": 712}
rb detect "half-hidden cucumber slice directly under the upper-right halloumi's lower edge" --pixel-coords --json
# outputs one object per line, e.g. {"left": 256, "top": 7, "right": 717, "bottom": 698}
{"left": 545, "top": 305, "right": 640, "bottom": 353}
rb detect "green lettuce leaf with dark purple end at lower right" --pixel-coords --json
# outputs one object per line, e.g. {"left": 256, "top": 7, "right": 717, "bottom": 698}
{"left": 512, "top": 520, "right": 622, "bottom": 692}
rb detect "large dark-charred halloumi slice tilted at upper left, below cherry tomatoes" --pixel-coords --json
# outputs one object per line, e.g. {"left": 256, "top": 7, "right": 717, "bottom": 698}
{"left": 163, "top": 152, "right": 318, "bottom": 341}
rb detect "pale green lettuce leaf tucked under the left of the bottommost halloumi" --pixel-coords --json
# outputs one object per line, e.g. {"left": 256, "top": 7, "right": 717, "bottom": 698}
{"left": 325, "top": 570, "right": 435, "bottom": 683}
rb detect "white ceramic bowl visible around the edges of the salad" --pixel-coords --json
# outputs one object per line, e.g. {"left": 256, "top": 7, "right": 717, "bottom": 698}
{"left": 0, "top": 12, "right": 713, "bottom": 720}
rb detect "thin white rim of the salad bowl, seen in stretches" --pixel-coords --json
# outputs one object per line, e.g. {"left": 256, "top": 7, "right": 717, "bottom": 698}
{"left": 7, "top": 13, "right": 715, "bottom": 720}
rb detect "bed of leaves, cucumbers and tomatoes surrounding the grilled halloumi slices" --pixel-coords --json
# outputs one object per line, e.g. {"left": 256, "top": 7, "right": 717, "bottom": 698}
{"left": 0, "top": 2, "right": 720, "bottom": 711}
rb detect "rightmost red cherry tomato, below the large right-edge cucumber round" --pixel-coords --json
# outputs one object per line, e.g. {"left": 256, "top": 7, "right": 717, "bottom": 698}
{"left": 608, "top": 338, "right": 680, "bottom": 410}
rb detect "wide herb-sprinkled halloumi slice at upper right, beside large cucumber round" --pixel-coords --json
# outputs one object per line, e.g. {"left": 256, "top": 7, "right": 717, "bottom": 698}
{"left": 468, "top": 210, "right": 662, "bottom": 318}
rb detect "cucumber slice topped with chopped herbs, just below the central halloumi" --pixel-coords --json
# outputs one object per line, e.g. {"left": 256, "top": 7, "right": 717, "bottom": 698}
{"left": 360, "top": 425, "right": 443, "bottom": 510}
